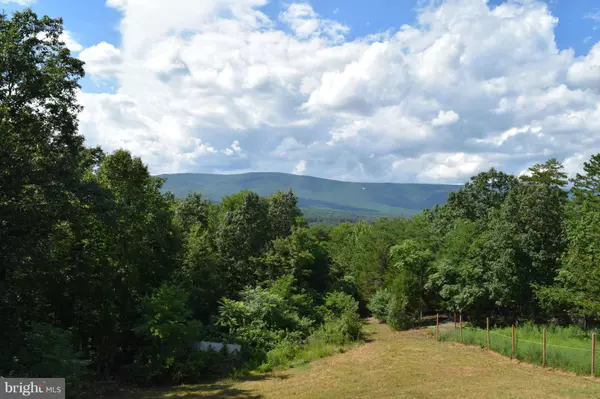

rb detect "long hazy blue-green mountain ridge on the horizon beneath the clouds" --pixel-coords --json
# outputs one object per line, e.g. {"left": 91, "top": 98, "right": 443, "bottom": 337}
{"left": 160, "top": 173, "right": 461, "bottom": 219}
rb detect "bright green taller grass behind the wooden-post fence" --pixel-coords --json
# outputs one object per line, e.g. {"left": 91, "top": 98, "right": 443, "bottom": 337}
{"left": 440, "top": 324, "right": 600, "bottom": 376}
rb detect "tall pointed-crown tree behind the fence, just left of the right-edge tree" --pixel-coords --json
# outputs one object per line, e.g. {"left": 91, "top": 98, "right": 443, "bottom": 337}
{"left": 490, "top": 159, "right": 567, "bottom": 318}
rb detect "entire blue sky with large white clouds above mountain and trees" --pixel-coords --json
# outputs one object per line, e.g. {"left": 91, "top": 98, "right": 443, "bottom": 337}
{"left": 0, "top": 0, "right": 600, "bottom": 183}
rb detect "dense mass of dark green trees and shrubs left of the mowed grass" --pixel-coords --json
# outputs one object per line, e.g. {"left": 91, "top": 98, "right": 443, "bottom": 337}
{"left": 0, "top": 10, "right": 361, "bottom": 395}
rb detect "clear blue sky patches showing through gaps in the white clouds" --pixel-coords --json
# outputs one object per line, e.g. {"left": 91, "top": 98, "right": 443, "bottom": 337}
{"left": 2, "top": 0, "right": 600, "bottom": 92}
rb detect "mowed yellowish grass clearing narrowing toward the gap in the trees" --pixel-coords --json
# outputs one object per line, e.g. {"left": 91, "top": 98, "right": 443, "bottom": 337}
{"left": 116, "top": 320, "right": 600, "bottom": 399}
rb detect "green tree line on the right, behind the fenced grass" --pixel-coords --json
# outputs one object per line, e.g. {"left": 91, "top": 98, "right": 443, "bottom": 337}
{"left": 338, "top": 154, "right": 600, "bottom": 328}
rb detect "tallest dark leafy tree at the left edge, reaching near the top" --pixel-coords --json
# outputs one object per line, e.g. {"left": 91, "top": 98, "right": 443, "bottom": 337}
{"left": 0, "top": 10, "right": 90, "bottom": 375}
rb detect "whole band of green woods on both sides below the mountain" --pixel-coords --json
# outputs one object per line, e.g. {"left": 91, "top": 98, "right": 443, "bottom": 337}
{"left": 0, "top": 7, "right": 600, "bottom": 396}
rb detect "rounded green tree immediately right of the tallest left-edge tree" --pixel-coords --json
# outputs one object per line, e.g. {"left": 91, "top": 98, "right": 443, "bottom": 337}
{"left": 90, "top": 150, "right": 181, "bottom": 373}
